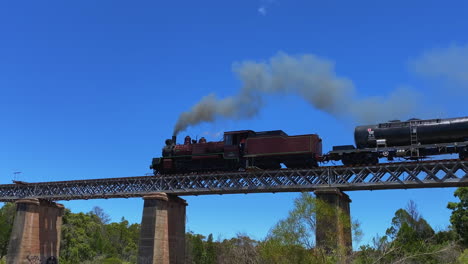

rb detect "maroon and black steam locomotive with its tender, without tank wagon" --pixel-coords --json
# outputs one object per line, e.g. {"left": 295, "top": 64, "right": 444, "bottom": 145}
{"left": 150, "top": 130, "right": 322, "bottom": 174}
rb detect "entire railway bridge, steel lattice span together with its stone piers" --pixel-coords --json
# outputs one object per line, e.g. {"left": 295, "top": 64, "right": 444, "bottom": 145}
{"left": 0, "top": 160, "right": 468, "bottom": 264}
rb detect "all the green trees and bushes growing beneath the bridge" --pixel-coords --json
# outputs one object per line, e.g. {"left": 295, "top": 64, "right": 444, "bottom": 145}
{"left": 0, "top": 188, "right": 468, "bottom": 264}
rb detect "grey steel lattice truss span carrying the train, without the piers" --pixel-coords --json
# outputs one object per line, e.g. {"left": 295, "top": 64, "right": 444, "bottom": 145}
{"left": 0, "top": 160, "right": 468, "bottom": 202}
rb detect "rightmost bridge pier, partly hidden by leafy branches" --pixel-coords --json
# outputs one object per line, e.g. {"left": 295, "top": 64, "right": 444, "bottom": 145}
{"left": 314, "top": 188, "right": 352, "bottom": 255}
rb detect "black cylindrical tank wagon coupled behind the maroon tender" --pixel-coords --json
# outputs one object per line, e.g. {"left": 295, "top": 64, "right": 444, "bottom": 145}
{"left": 327, "top": 117, "right": 468, "bottom": 165}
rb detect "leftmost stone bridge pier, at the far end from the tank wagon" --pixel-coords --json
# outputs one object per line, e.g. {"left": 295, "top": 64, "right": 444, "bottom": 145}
{"left": 7, "top": 199, "right": 63, "bottom": 264}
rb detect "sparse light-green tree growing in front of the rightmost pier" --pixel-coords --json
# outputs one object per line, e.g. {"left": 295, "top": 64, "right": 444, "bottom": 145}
{"left": 259, "top": 193, "right": 362, "bottom": 263}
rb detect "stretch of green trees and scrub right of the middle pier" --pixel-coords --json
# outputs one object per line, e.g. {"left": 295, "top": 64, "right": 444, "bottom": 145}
{"left": 183, "top": 188, "right": 468, "bottom": 264}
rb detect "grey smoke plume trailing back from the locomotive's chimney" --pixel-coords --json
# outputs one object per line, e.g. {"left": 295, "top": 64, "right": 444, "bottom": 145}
{"left": 174, "top": 53, "right": 417, "bottom": 135}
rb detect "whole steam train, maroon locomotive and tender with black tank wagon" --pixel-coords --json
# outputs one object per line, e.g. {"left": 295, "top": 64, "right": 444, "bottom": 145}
{"left": 150, "top": 117, "right": 468, "bottom": 175}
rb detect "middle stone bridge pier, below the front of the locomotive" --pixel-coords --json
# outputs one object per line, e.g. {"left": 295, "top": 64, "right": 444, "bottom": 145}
{"left": 138, "top": 193, "right": 187, "bottom": 264}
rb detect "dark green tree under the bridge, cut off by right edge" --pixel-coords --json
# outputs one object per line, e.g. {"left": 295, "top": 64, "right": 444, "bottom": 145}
{"left": 447, "top": 187, "right": 468, "bottom": 247}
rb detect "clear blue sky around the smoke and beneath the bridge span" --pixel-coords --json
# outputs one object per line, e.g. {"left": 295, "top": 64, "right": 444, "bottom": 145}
{"left": 0, "top": 0, "right": 468, "bottom": 245}
